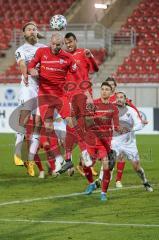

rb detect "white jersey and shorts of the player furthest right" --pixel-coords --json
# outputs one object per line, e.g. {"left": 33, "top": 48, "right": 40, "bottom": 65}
{"left": 111, "top": 106, "right": 143, "bottom": 161}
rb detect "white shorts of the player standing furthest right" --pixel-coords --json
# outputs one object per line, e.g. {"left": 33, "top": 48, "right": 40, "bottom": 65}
{"left": 111, "top": 137, "right": 139, "bottom": 161}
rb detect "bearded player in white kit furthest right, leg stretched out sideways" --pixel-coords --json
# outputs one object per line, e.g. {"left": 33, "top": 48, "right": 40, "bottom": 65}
{"left": 112, "top": 92, "right": 153, "bottom": 192}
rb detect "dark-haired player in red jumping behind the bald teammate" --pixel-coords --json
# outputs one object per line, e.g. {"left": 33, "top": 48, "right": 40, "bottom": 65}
{"left": 64, "top": 32, "right": 98, "bottom": 174}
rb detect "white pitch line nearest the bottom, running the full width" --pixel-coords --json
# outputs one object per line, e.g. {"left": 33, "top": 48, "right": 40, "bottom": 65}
{"left": 0, "top": 219, "right": 159, "bottom": 228}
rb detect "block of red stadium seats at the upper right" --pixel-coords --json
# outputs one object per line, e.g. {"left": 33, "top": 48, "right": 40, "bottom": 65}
{"left": 115, "top": 0, "right": 159, "bottom": 83}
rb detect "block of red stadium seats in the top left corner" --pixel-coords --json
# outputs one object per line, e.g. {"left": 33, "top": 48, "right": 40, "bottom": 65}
{"left": 0, "top": 0, "right": 75, "bottom": 50}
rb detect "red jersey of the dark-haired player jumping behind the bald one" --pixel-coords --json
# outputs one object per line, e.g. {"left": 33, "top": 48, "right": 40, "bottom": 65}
{"left": 67, "top": 48, "right": 99, "bottom": 94}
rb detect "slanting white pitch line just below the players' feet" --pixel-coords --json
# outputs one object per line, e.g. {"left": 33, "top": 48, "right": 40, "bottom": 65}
{"left": 0, "top": 185, "right": 147, "bottom": 207}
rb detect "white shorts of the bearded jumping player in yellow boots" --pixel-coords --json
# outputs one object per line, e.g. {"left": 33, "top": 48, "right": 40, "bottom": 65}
{"left": 18, "top": 85, "right": 39, "bottom": 114}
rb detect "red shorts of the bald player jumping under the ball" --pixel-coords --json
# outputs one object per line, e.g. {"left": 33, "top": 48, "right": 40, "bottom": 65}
{"left": 39, "top": 94, "right": 70, "bottom": 121}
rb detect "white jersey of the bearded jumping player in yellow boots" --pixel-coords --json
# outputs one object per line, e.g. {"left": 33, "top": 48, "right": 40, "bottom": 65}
{"left": 15, "top": 43, "right": 46, "bottom": 86}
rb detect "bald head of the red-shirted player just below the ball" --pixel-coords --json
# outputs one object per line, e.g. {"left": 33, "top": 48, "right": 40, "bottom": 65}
{"left": 50, "top": 32, "right": 64, "bottom": 55}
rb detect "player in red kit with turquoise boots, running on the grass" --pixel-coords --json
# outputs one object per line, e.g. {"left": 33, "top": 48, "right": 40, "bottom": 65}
{"left": 84, "top": 82, "right": 120, "bottom": 201}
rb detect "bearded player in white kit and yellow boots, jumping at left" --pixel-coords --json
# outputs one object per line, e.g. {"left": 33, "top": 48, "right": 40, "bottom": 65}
{"left": 14, "top": 22, "right": 45, "bottom": 176}
